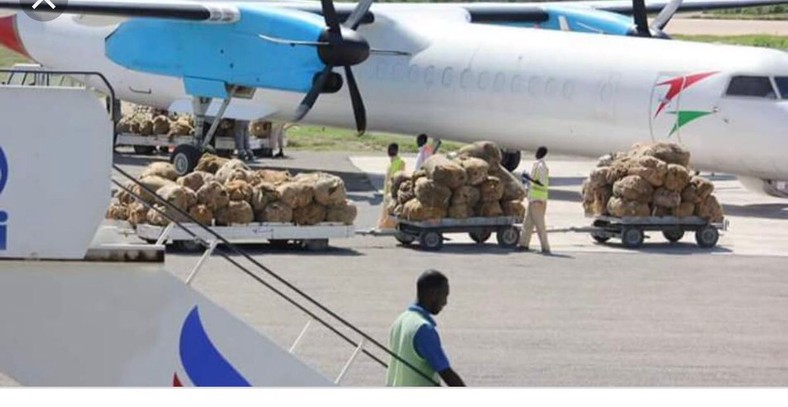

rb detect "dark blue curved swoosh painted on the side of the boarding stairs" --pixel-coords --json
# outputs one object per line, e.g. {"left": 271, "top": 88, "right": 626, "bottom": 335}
{"left": 180, "top": 306, "right": 251, "bottom": 387}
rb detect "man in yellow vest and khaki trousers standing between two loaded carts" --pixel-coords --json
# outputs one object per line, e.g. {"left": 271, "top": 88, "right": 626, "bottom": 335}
{"left": 520, "top": 146, "right": 551, "bottom": 254}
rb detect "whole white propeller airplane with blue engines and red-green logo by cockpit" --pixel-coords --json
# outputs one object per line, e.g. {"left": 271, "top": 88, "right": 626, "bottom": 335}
{"left": 0, "top": 0, "right": 788, "bottom": 197}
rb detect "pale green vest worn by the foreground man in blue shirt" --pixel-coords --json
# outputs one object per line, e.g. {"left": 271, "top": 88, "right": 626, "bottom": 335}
{"left": 386, "top": 310, "right": 440, "bottom": 387}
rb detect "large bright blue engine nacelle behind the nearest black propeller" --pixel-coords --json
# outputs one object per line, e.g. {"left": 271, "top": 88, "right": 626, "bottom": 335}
{"left": 106, "top": 5, "right": 325, "bottom": 97}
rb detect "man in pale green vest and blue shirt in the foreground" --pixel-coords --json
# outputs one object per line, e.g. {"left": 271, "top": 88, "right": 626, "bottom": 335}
{"left": 386, "top": 270, "right": 465, "bottom": 386}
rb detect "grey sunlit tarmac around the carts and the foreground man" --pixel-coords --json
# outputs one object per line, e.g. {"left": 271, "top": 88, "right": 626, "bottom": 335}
{"left": 0, "top": 152, "right": 788, "bottom": 387}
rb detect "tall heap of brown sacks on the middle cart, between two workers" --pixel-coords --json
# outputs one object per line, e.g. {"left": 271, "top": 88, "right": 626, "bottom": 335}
{"left": 387, "top": 141, "right": 525, "bottom": 221}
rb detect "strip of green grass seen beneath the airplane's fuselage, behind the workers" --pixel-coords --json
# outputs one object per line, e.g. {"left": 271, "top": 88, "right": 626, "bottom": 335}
{"left": 287, "top": 125, "right": 463, "bottom": 153}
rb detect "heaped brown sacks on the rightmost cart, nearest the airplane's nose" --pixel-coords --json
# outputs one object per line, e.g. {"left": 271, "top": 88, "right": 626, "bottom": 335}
{"left": 582, "top": 142, "right": 724, "bottom": 222}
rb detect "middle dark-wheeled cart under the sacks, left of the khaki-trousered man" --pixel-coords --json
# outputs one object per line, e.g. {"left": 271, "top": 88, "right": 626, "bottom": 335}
{"left": 394, "top": 216, "right": 520, "bottom": 251}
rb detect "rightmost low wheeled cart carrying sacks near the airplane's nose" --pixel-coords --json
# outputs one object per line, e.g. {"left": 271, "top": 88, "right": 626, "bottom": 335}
{"left": 582, "top": 216, "right": 729, "bottom": 249}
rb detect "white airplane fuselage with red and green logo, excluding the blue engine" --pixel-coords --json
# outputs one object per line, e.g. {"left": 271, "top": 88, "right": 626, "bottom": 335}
{"left": 10, "top": 10, "right": 788, "bottom": 180}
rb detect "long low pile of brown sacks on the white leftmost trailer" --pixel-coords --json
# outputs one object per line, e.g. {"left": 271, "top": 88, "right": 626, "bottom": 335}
{"left": 106, "top": 154, "right": 357, "bottom": 227}
